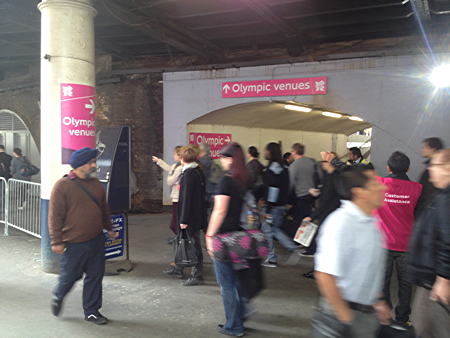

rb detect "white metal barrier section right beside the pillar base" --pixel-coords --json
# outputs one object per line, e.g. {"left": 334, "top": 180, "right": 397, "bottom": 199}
{"left": 5, "top": 179, "right": 41, "bottom": 238}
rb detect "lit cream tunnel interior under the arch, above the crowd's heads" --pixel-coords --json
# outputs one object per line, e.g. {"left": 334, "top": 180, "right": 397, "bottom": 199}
{"left": 187, "top": 101, "right": 372, "bottom": 160}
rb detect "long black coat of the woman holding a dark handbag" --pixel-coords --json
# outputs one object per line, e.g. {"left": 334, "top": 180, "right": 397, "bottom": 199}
{"left": 178, "top": 167, "right": 207, "bottom": 232}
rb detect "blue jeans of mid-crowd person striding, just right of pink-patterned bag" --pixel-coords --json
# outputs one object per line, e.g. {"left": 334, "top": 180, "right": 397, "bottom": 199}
{"left": 261, "top": 206, "right": 297, "bottom": 263}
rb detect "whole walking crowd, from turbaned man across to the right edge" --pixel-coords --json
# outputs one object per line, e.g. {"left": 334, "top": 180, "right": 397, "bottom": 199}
{"left": 44, "top": 138, "right": 450, "bottom": 338}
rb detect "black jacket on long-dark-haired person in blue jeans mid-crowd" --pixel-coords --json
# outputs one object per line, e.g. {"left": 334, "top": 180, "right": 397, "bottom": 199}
{"left": 263, "top": 162, "right": 289, "bottom": 206}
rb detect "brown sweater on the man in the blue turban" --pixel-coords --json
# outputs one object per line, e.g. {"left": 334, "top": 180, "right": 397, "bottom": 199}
{"left": 48, "top": 172, "right": 112, "bottom": 245}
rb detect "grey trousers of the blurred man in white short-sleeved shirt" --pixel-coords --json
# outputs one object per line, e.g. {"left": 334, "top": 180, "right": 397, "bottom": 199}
{"left": 311, "top": 298, "right": 379, "bottom": 338}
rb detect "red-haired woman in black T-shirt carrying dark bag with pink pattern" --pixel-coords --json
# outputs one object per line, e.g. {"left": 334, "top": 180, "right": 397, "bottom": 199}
{"left": 206, "top": 143, "right": 265, "bottom": 337}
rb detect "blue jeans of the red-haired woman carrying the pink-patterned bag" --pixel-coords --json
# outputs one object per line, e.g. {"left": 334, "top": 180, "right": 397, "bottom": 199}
{"left": 214, "top": 260, "right": 245, "bottom": 334}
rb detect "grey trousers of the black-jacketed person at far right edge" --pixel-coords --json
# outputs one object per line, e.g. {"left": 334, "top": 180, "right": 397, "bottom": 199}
{"left": 412, "top": 287, "right": 450, "bottom": 338}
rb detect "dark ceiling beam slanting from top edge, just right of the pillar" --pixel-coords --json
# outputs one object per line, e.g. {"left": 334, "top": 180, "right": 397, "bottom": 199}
{"left": 101, "top": 0, "right": 219, "bottom": 59}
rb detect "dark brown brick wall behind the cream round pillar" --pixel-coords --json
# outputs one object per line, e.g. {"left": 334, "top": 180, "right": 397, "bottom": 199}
{"left": 0, "top": 74, "right": 163, "bottom": 212}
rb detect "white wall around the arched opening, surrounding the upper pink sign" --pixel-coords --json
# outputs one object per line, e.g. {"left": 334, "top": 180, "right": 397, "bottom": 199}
{"left": 164, "top": 54, "right": 450, "bottom": 203}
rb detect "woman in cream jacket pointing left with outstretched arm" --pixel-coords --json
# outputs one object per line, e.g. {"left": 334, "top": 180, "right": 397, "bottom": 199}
{"left": 152, "top": 146, "right": 182, "bottom": 238}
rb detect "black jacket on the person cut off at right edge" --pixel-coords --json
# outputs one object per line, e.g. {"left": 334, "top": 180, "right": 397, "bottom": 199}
{"left": 409, "top": 186, "right": 450, "bottom": 287}
